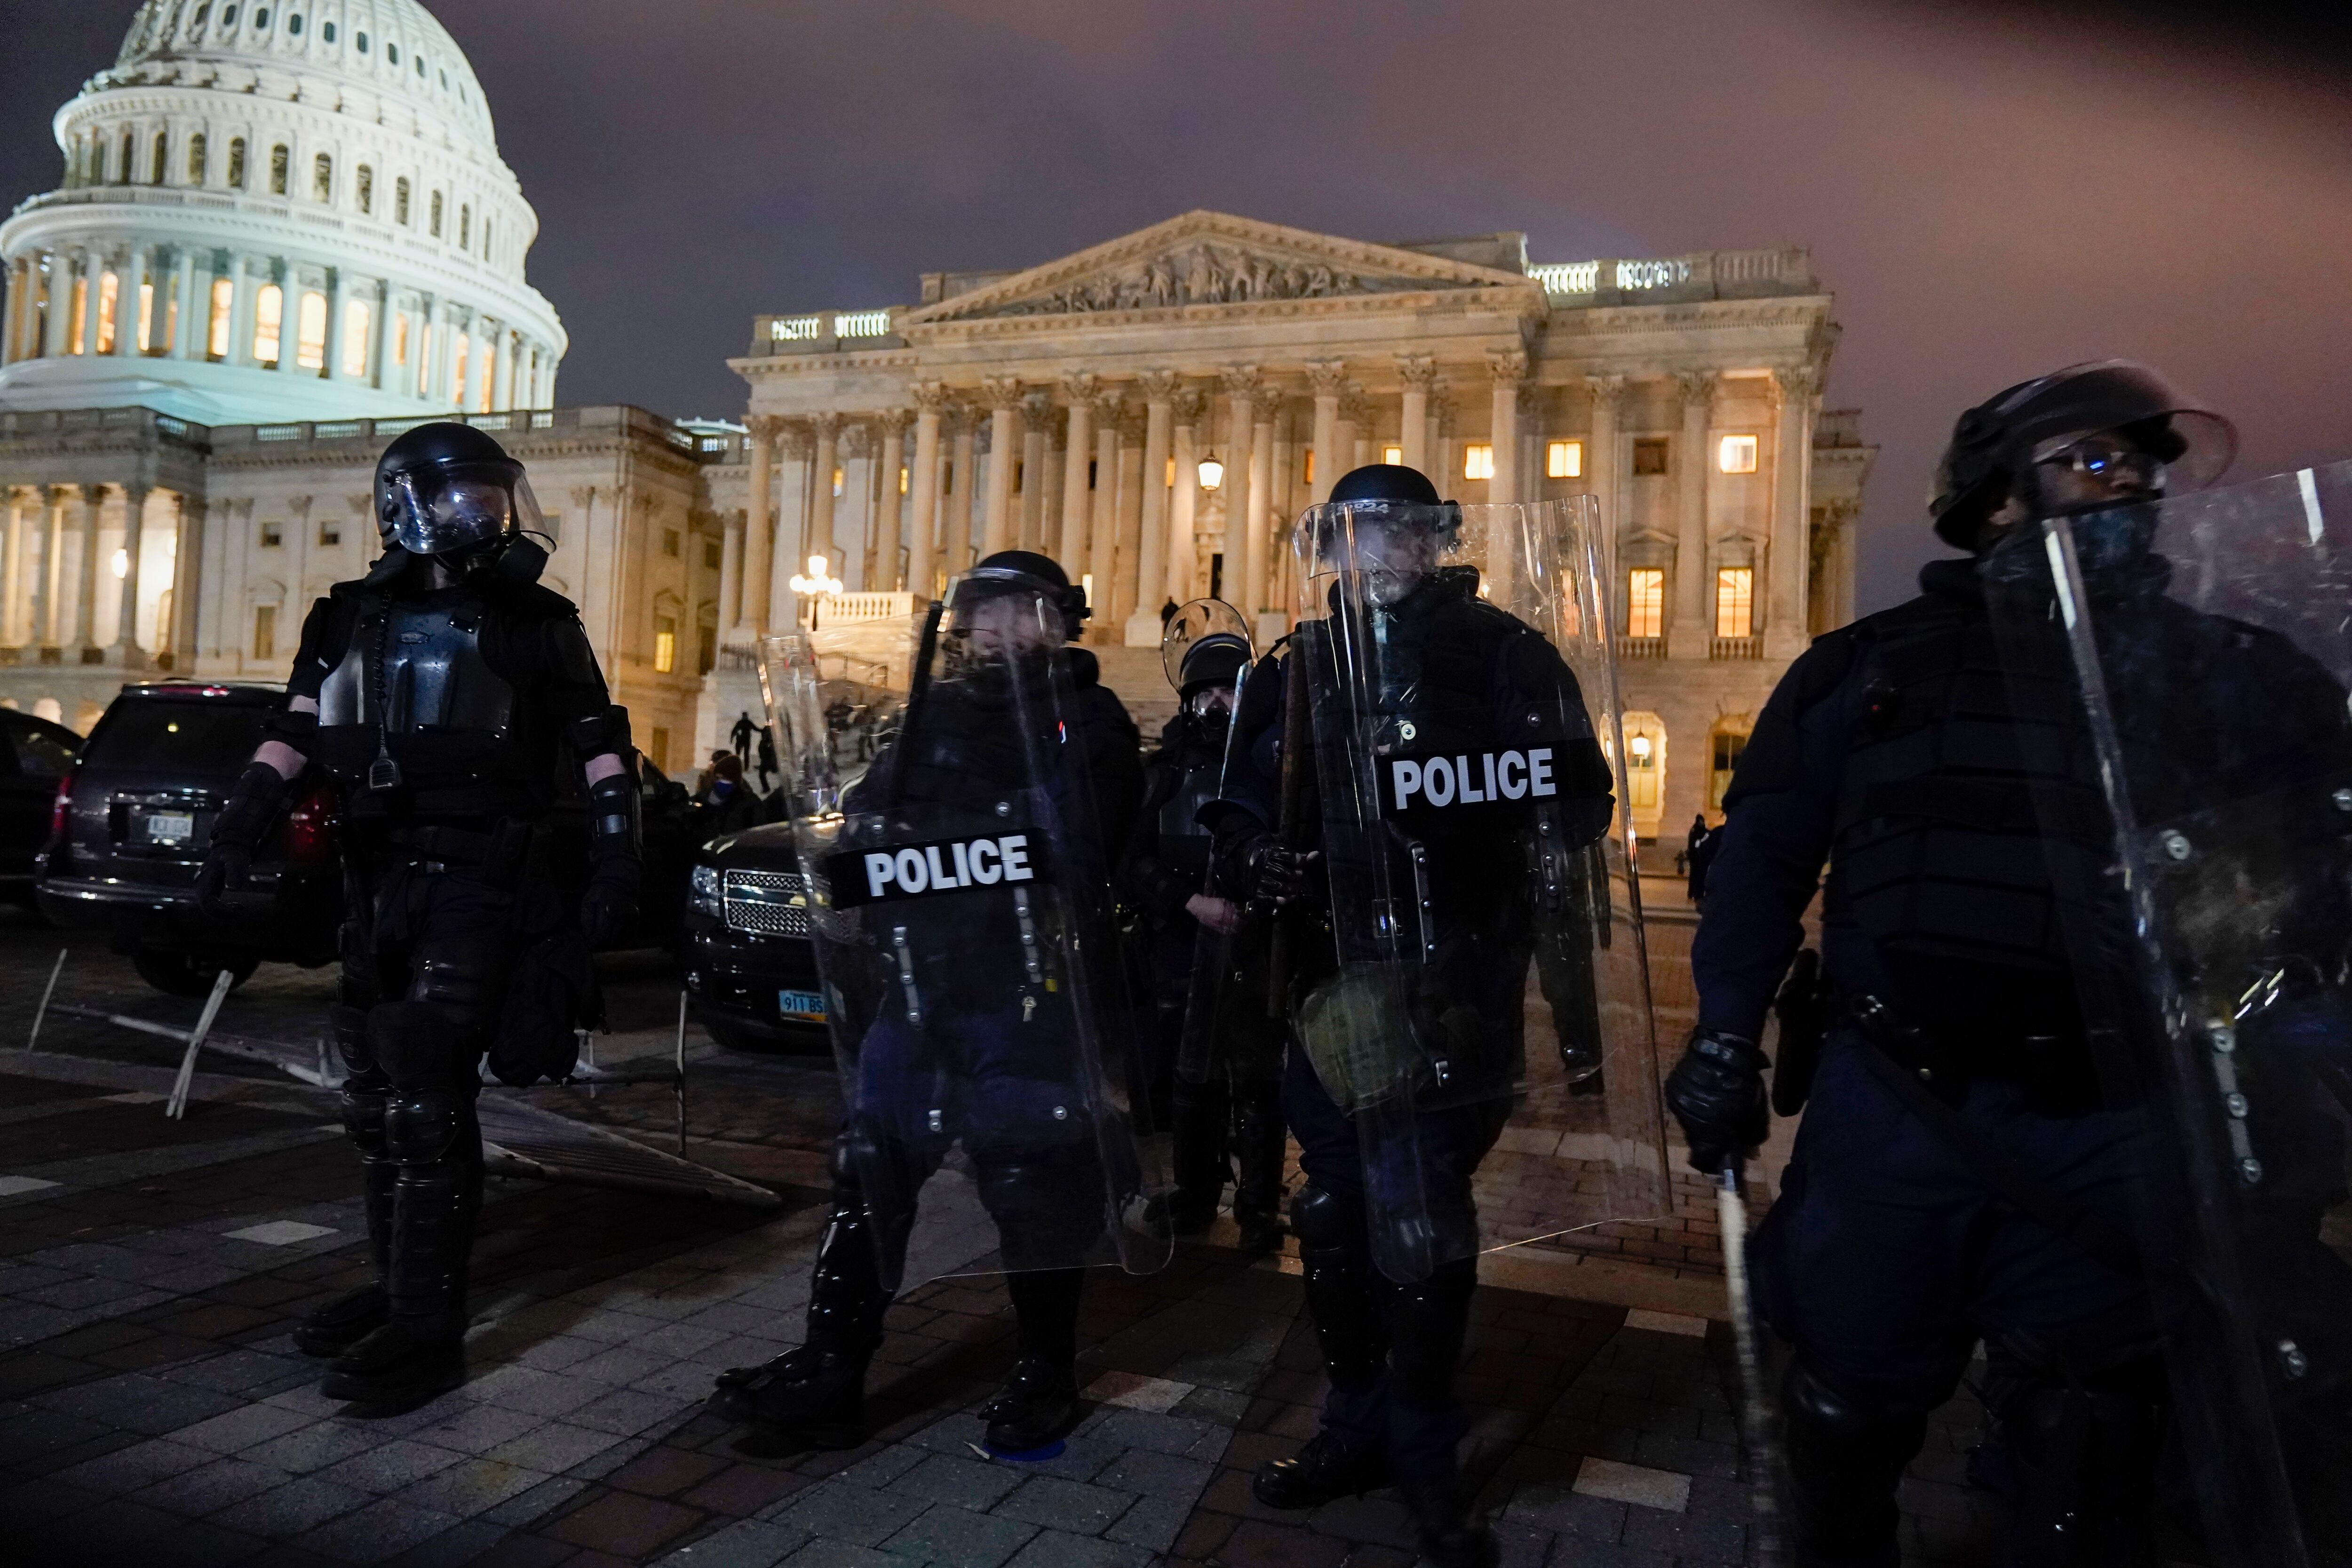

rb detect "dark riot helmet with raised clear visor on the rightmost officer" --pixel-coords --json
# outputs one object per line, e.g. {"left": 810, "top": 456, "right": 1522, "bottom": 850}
{"left": 1929, "top": 360, "right": 2237, "bottom": 550}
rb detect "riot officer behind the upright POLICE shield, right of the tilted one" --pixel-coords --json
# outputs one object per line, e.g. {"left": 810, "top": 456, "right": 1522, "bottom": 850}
{"left": 1211, "top": 465, "right": 1611, "bottom": 1566}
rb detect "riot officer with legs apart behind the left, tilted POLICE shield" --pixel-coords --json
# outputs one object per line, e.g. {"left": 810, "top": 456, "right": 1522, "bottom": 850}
{"left": 710, "top": 550, "right": 1143, "bottom": 1453}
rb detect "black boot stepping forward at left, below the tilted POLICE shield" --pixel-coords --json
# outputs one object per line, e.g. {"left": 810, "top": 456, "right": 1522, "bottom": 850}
{"left": 708, "top": 1170, "right": 889, "bottom": 1453}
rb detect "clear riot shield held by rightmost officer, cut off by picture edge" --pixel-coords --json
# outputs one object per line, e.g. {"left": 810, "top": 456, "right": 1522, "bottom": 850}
{"left": 1983, "top": 465, "right": 2352, "bottom": 1568}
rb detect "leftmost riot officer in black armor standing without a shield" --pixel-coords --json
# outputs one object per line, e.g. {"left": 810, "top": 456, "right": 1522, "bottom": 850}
{"left": 198, "top": 423, "right": 642, "bottom": 1403}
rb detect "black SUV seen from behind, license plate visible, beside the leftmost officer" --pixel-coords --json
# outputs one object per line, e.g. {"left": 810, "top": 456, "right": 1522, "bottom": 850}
{"left": 38, "top": 682, "right": 343, "bottom": 995}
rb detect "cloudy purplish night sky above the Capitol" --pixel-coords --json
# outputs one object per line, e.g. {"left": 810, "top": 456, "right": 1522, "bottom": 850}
{"left": 0, "top": 0, "right": 2352, "bottom": 609}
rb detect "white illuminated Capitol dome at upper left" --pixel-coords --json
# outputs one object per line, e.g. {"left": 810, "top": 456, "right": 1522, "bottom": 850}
{"left": 0, "top": 0, "right": 567, "bottom": 425}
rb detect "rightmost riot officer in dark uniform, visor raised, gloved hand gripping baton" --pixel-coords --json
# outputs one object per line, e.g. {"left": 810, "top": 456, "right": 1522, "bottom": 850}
{"left": 1668, "top": 362, "right": 2343, "bottom": 1568}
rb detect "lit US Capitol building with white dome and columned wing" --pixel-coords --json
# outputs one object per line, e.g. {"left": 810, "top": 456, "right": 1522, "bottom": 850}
{"left": 0, "top": 0, "right": 1875, "bottom": 842}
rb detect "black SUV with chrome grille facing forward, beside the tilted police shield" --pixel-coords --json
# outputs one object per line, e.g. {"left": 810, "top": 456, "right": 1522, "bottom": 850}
{"left": 680, "top": 823, "right": 828, "bottom": 1053}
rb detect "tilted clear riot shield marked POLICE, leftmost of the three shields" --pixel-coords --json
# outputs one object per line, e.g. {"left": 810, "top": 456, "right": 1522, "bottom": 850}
{"left": 760, "top": 573, "right": 1171, "bottom": 1290}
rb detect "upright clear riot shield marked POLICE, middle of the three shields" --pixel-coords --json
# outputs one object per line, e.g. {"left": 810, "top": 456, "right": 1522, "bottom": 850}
{"left": 1287, "top": 498, "right": 1668, "bottom": 1281}
